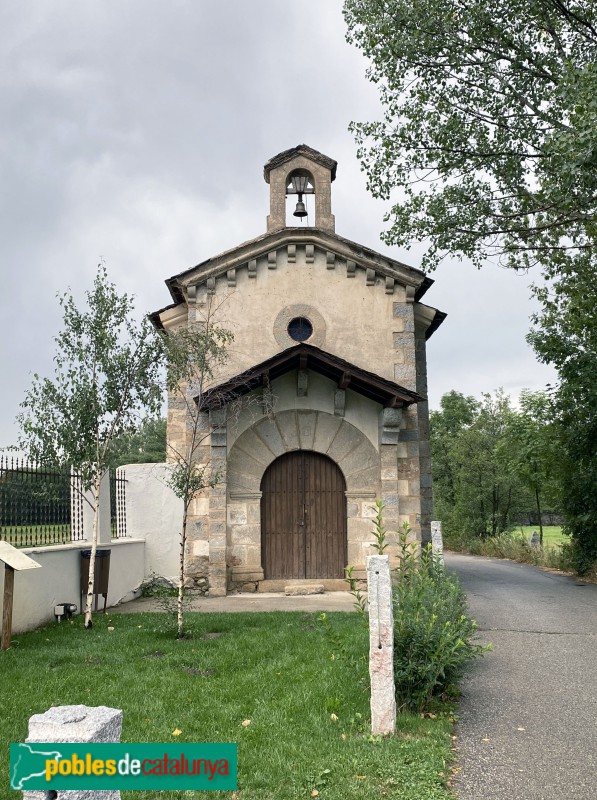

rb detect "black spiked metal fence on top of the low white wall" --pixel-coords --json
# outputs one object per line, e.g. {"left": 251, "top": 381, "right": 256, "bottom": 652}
{"left": 0, "top": 455, "right": 126, "bottom": 547}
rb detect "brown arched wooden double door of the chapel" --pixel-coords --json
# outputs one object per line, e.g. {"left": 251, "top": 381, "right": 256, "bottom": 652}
{"left": 261, "top": 450, "right": 346, "bottom": 579}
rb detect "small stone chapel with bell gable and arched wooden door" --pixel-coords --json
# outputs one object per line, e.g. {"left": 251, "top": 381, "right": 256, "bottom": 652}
{"left": 152, "top": 145, "right": 445, "bottom": 596}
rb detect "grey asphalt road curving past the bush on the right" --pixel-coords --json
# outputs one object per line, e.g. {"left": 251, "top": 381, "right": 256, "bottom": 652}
{"left": 446, "top": 553, "right": 597, "bottom": 800}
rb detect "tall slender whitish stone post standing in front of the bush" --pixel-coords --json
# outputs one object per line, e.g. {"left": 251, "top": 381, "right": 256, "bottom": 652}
{"left": 367, "top": 556, "right": 396, "bottom": 736}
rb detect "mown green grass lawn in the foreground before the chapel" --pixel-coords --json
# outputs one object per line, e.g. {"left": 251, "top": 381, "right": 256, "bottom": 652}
{"left": 0, "top": 612, "right": 452, "bottom": 800}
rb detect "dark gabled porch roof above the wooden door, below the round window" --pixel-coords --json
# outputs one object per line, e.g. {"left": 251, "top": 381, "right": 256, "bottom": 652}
{"left": 200, "top": 343, "right": 425, "bottom": 409}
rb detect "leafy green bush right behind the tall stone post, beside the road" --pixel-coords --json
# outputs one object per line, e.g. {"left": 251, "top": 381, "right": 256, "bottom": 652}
{"left": 394, "top": 528, "right": 489, "bottom": 710}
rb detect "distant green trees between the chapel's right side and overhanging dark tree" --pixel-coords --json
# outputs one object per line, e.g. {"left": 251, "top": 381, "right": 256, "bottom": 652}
{"left": 430, "top": 390, "right": 561, "bottom": 552}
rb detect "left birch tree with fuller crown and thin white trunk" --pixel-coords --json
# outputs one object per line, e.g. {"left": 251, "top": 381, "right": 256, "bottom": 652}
{"left": 18, "top": 264, "right": 163, "bottom": 629}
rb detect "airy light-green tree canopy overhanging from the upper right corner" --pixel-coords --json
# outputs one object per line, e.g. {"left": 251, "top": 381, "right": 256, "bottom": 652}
{"left": 344, "top": 0, "right": 597, "bottom": 275}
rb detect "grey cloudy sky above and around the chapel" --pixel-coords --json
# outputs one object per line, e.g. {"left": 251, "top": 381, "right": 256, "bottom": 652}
{"left": 0, "top": 0, "right": 553, "bottom": 447}
